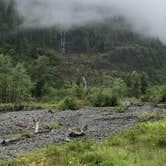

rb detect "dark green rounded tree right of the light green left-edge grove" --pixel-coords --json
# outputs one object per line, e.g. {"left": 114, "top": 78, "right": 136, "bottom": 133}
{"left": 29, "top": 56, "right": 60, "bottom": 99}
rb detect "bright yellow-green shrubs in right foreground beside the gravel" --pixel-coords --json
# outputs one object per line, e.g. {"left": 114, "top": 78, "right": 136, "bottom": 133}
{"left": 108, "top": 119, "right": 166, "bottom": 147}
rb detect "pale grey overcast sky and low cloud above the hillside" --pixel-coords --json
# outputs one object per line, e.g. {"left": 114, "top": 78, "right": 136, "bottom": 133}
{"left": 15, "top": 0, "right": 166, "bottom": 42}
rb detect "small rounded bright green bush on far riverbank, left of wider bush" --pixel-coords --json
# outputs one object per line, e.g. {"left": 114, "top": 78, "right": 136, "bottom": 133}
{"left": 58, "top": 97, "right": 84, "bottom": 110}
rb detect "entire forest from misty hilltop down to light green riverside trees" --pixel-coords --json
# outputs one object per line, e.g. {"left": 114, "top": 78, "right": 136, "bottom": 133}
{"left": 0, "top": 0, "right": 166, "bottom": 106}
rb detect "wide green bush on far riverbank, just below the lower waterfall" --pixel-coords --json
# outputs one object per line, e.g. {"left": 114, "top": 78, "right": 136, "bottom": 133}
{"left": 86, "top": 88, "right": 118, "bottom": 107}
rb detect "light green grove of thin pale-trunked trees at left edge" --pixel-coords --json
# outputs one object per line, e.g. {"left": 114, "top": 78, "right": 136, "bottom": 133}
{"left": 0, "top": 55, "right": 33, "bottom": 103}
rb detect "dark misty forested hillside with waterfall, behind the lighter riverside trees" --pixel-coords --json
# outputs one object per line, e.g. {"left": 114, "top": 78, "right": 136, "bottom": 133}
{"left": 0, "top": 0, "right": 166, "bottom": 104}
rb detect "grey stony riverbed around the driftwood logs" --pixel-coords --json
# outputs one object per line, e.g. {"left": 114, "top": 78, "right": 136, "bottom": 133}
{"left": 0, "top": 105, "right": 166, "bottom": 161}
